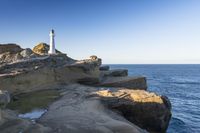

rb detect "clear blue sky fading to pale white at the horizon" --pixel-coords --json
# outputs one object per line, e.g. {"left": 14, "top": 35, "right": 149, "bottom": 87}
{"left": 0, "top": 0, "right": 200, "bottom": 64}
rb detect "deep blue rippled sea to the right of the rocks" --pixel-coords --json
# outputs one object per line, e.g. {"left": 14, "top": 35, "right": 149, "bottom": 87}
{"left": 110, "top": 65, "right": 200, "bottom": 133}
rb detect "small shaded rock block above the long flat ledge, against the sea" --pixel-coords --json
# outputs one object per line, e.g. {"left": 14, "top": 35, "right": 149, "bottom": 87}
{"left": 101, "top": 69, "right": 128, "bottom": 77}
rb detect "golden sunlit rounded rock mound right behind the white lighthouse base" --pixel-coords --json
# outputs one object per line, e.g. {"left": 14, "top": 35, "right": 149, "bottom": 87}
{"left": 33, "top": 43, "right": 61, "bottom": 55}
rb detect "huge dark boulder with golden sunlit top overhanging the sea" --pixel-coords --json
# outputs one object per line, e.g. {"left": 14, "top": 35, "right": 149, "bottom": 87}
{"left": 96, "top": 88, "right": 171, "bottom": 133}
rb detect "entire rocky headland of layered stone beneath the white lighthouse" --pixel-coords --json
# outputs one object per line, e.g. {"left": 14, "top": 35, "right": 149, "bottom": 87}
{"left": 0, "top": 44, "right": 171, "bottom": 133}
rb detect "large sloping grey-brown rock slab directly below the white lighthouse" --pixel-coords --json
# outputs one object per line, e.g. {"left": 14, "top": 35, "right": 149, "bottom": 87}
{"left": 0, "top": 54, "right": 101, "bottom": 93}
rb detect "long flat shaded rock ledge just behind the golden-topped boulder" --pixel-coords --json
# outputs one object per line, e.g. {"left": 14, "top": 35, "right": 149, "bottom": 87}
{"left": 98, "top": 77, "right": 147, "bottom": 90}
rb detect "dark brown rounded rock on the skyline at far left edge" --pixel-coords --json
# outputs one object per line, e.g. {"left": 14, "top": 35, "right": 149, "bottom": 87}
{"left": 0, "top": 44, "right": 23, "bottom": 54}
